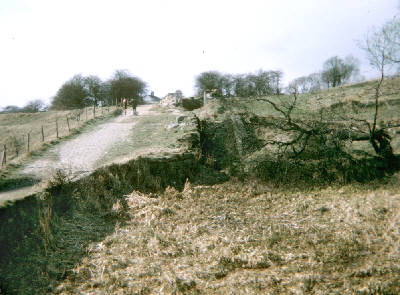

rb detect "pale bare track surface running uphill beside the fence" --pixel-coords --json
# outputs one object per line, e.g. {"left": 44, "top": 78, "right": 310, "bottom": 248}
{"left": 0, "top": 105, "right": 155, "bottom": 205}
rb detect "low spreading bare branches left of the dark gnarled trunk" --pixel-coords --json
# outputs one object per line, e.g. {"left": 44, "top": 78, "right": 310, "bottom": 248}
{"left": 258, "top": 93, "right": 354, "bottom": 159}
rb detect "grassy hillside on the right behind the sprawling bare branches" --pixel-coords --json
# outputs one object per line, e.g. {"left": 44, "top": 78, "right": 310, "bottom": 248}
{"left": 195, "top": 78, "right": 400, "bottom": 181}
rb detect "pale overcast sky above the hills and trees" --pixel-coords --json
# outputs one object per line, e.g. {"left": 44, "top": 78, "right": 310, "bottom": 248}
{"left": 0, "top": 0, "right": 399, "bottom": 107}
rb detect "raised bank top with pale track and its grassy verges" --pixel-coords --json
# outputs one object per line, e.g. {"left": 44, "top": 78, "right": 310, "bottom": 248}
{"left": 0, "top": 105, "right": 197, "bottom": 204}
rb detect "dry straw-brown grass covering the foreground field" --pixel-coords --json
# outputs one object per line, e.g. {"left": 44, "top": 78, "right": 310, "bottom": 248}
{"left": 54, "top": 175, "right": 400, "bottom": 294}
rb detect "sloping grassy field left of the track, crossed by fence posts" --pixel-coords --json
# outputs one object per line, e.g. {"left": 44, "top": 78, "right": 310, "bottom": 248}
{"left": 0, "top": 107, "right": 120, "bottom": 203}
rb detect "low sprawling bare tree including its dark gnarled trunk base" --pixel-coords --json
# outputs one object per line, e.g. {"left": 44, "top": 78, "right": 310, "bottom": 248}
{"left": 257, "top": 92, "right": 397, "bottom": 177}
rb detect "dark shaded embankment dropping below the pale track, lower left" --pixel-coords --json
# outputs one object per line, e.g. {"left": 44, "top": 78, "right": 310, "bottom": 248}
{"left": 0, "top": 152, "right": 198, "bottom": 294}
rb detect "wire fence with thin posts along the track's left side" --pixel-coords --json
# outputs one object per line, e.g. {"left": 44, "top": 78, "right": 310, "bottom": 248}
{"left": 0, "top": 106, "right": 117, "bottom": 168}
